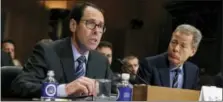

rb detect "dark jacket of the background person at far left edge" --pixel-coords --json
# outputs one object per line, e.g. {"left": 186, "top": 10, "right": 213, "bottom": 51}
{"left": 1, "top": 50, "right": 14, "bottom": 66}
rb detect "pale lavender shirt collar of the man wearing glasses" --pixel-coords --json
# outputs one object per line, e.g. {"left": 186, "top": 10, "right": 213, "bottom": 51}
{"left": 71, "top": 41, "right": 89, "bottom": 62}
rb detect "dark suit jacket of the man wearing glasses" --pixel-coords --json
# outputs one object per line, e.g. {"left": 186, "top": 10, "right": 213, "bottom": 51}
{"left": 12, "top": 38, "right": 112, "bottom": 98}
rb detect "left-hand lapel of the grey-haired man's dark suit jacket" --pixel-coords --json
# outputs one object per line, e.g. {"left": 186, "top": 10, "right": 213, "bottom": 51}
{"left": 158, "top": 53, "right": 170, "bottom": 87}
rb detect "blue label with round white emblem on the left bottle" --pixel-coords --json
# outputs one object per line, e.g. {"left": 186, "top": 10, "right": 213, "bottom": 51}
{"left": 42, "top": 82, "right": 57, "bottom": 97}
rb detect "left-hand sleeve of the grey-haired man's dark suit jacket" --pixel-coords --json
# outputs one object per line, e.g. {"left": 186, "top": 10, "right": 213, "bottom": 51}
{"left": 136, "top": 59, "right": 152, "bottom": 85}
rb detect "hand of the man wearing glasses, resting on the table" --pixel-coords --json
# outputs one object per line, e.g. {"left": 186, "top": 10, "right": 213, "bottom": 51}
{"left": 66, "top": 77, "right": 96, "bottom": 95}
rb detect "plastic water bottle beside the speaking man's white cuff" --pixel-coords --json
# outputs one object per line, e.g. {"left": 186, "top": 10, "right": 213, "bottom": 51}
{"left": 41, "top": 70, "right": 58, "bottom": 101}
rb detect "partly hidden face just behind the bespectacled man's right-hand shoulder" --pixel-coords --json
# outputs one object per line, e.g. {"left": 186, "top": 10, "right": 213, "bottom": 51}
{"left": 97, "top": 47, "right": 112, "bottom": 65}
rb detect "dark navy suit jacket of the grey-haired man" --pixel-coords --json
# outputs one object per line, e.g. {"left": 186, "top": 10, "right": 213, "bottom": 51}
{"left": 136, "top": 53, "right": 199, "bottom": 89}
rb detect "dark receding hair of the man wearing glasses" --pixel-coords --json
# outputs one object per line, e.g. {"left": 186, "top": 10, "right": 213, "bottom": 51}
{"left": 69, "top": 2, "right": 103, "bottom": 24}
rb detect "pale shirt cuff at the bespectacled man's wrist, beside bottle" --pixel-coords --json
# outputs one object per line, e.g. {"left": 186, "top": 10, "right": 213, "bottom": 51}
{"left": 57, "top": 84, "right": 68, "bottom": 97}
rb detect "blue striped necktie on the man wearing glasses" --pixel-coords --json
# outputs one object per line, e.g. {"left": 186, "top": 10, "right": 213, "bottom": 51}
{"left": 75, "top": 56, "right": 86, "bottom": 78}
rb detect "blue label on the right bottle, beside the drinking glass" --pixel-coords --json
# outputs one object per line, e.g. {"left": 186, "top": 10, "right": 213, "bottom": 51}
{"left": 117, "top": 87, "right": 132, "bottom": 101}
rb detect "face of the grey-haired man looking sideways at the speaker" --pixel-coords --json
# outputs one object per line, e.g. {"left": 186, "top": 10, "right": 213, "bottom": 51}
{"left": 168, "top": 32, "right": 197, "bottom": 66}
